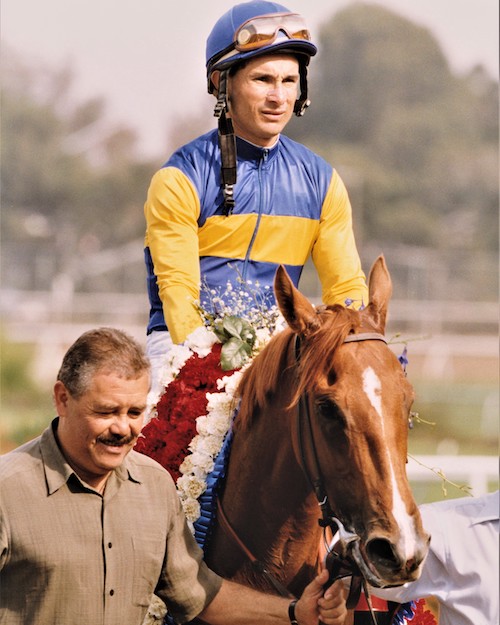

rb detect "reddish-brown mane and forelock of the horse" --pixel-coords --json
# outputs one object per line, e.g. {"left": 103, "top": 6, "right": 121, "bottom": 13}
{"left": 238, "top": 305, "right": 361, "bottom": 428}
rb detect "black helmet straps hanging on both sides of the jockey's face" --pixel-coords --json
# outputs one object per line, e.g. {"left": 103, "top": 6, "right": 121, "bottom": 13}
{"left": 214, "top": 63, "right": 311, "bottom": 217}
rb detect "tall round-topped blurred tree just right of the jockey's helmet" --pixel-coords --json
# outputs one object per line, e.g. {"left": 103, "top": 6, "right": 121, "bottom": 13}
{"left": 307, "top": 3, "right": 451, "bottom": 143}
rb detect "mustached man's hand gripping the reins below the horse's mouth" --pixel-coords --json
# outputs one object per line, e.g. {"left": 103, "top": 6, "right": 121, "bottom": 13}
{"left": 295, "top": 569, "right": 347, "bottom": 625}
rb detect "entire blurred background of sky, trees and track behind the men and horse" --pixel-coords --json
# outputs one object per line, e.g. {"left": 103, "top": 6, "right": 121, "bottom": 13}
{"left": 0, "top": 0, "right": 499, "bottom": 502}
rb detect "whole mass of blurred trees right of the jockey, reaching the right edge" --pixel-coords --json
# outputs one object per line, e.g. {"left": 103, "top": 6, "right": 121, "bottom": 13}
{"left": 290, "top": 3, "right": 498, "bottom": 250}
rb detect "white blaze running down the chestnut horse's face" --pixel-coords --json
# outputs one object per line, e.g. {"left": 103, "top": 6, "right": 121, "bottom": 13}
{"left": 363, "top": 367, "right": 417, "bottom": 559}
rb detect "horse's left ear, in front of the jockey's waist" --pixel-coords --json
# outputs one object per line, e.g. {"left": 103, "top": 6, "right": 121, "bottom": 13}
{"left": 274, "top": 265, "right": 319, "bottom": 335}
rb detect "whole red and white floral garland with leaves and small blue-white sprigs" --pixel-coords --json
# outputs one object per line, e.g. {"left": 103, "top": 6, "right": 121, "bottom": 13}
{"left": 135, "top": 276, "right": 285, "bottom": 534}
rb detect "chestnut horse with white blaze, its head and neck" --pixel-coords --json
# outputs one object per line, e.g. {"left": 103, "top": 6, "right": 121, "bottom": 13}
{"left": 205, "top": 256, "right": 428, "bottom": 596}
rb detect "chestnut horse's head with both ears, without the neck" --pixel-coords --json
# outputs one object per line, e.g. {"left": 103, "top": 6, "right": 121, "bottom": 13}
{"left": 275, "top": 257, "right": 429, "bottom": 587}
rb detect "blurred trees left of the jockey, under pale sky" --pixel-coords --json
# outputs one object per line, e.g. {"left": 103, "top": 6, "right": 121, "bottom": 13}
{"left": 1, "top": 50, "right": 154, "bottom": 288}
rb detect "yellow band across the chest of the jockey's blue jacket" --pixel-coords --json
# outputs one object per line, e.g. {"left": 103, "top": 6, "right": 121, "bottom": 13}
{"left": 199, "top": 214, "right": 319, "bottom": 265}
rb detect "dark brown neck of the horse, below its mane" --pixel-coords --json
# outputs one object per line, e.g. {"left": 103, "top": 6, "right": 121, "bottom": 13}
{"left": 205, "top": 385, "right": 319, "bottom": 592}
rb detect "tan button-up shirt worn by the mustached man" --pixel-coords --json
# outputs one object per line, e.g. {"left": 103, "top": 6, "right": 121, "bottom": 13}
{"left": 0, "top": 420, "right": 221, "bottom": 625}
